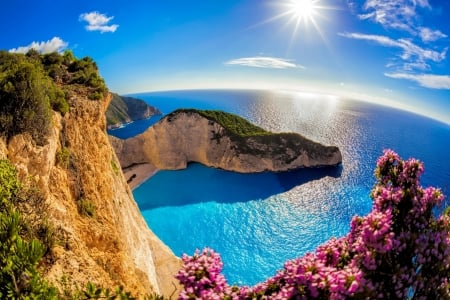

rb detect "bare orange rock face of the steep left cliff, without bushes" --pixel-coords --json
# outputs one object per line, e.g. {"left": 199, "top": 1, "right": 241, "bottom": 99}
{"left": 0, "top": 93, "right": 180, "bottom": 296}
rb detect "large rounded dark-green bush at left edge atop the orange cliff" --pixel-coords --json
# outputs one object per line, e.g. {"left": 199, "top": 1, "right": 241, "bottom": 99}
{"left": 0, "top": 51, "right": 69, "bottom": 145}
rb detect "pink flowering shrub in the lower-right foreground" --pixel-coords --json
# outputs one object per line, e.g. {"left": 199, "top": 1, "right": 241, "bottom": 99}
{"left": 176, "top": 150, "right": 450, "bottom": 300}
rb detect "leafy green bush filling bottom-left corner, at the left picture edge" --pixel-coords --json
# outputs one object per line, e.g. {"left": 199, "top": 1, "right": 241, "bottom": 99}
{"left": 0, "top": 160, "right": 57, "bottom": 299}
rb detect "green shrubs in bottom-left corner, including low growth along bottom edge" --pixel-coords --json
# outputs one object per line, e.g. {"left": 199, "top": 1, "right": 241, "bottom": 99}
{"left": 0, "top": 160, "right": 163, "bottom": 300}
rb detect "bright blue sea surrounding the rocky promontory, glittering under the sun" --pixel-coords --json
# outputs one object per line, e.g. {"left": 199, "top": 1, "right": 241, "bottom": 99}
{"left": 110, "top": 90, "right": 450, "bottom": 285}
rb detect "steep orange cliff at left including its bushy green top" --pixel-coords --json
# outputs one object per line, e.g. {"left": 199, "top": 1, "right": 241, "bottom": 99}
{"left": 0, "top": 51, "right": 180, "bottom": 296}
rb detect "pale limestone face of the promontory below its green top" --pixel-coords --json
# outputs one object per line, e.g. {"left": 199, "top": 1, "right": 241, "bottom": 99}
{"left": 110, "top": 111, "right": 342, "bottom": 173}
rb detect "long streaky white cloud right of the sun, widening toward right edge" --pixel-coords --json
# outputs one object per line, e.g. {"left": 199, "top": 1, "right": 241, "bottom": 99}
{"left": 338, "top": 32, "right": 448, "bottom": 70}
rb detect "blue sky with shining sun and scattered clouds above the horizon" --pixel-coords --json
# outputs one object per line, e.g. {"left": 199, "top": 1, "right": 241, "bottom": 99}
{"left": 0, "top": 0, "right": 450, "bottom": 124}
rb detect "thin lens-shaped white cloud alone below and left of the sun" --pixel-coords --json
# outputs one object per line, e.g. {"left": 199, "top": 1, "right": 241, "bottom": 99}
{"left": 225, "top": 56, "right": 305, "bottom": 69}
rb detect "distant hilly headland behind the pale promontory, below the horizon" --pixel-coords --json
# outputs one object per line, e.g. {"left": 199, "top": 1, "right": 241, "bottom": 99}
{"left": 106, "top": 93, "right": 161, "bottom": 129}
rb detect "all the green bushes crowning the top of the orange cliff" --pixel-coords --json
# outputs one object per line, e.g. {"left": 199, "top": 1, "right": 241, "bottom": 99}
{"left": 0, "top": 50, "right": 108, "bottom": 144}
